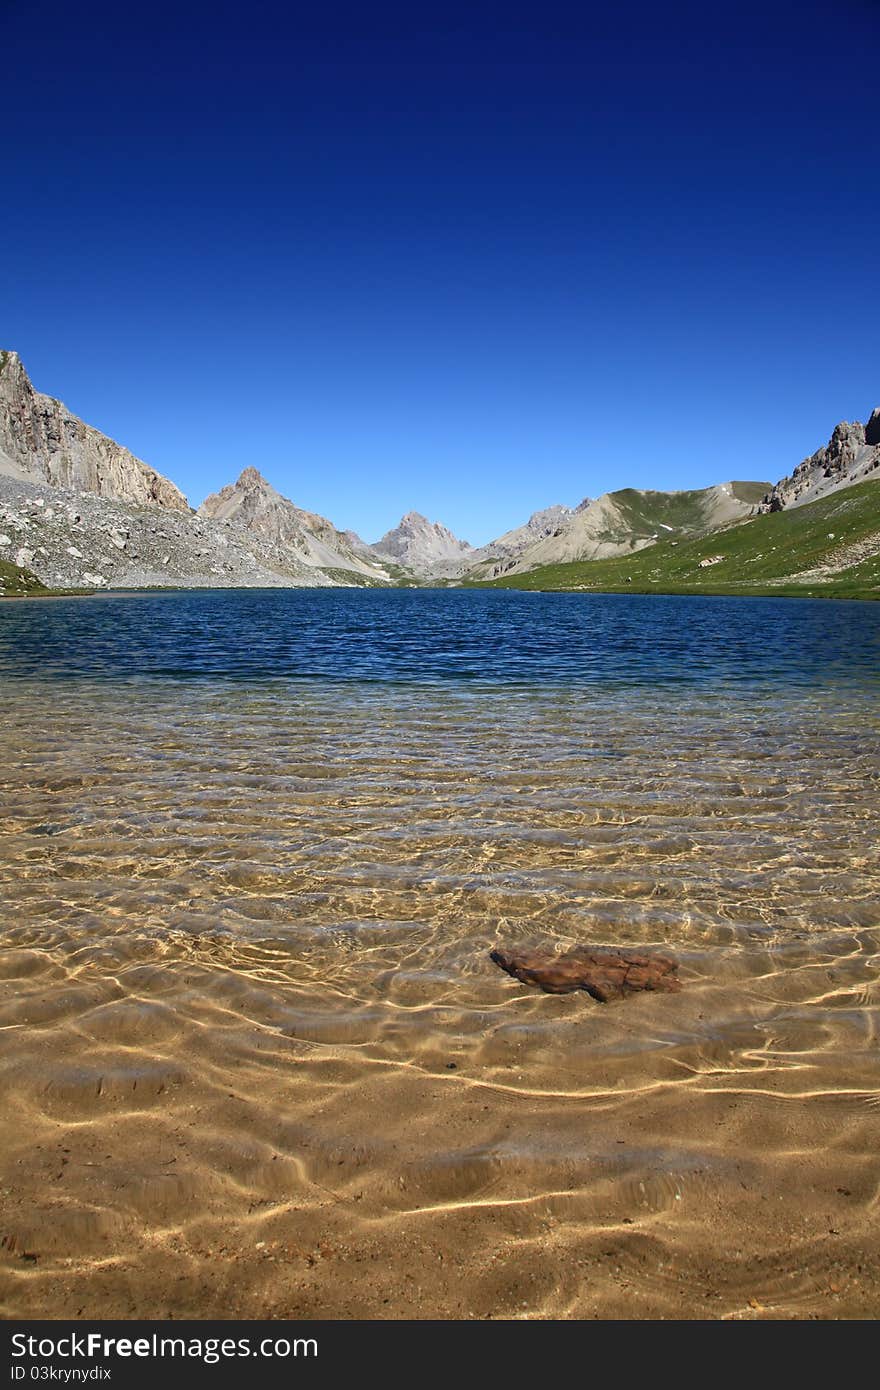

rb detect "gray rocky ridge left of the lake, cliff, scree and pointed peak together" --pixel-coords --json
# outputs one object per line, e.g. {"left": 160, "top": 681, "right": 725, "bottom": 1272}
{"left": 0, "top": 352, "right": 405, "bottom": 592}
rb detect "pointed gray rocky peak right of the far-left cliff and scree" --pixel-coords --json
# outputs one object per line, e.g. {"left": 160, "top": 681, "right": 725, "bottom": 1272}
{"left": 199, "top": 468, "right": 391, "bottom": 582}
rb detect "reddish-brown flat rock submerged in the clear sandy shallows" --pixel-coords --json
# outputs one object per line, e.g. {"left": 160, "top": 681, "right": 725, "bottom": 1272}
{"left": 489, "top": 947, "right": 681, "bottom": 1004}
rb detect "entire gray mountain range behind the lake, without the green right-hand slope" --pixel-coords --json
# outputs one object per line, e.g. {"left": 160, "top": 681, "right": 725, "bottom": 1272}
{"left": 0, "top": 352, "right": 880, "bottom": 589}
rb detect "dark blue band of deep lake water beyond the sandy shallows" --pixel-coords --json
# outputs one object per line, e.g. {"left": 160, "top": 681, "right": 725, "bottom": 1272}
{"left": 0, "top": 589, "right": 880, "bottom": 687}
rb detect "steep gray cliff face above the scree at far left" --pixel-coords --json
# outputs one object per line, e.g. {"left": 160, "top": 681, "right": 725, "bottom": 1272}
{"left": 0, "top": 352, "right": 189, "bottom": 512}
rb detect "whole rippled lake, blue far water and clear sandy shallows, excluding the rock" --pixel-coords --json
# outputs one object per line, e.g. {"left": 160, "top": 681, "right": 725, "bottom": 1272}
{"left": 0, "top": 589, "right": 880, "bottom": 1316}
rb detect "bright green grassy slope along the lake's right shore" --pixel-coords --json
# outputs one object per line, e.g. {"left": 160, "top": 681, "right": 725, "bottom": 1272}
{"left": 478, "top": 481, "right": 880, "bottom": 598}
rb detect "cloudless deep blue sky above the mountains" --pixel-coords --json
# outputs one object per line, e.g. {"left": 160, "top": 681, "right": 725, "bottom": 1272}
{"left": 0, "top": 0, "right": 880, "bottom": 543}
